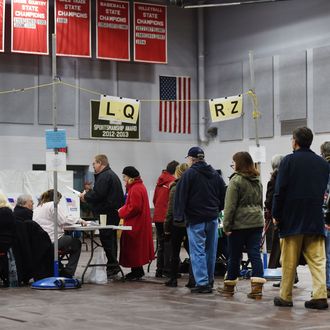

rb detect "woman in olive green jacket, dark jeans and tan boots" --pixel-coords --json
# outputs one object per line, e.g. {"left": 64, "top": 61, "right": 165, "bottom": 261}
{"left": 218, "top": 151, "right": 266, "bottom": 299}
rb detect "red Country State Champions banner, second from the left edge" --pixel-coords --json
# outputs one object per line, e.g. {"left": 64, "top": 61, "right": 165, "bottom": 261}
{"left": 11, "top": 0, "right": 49, "bottom": 55}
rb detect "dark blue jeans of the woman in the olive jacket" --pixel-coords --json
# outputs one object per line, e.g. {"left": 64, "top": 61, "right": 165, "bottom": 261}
{"left": 227, "top": 228, "right": 264, "bottom": 280}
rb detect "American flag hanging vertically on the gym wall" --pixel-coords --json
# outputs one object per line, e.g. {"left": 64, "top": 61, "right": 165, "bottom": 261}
{"left": 159, "top": 76, "right": 191, "bottom": 134}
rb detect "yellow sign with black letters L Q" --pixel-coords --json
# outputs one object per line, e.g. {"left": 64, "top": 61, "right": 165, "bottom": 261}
{"left": 99, "top": 95, "right": 140, "bottom": 124}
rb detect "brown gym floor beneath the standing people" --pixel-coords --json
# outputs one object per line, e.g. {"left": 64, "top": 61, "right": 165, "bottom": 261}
{"left": 0, "top": 245, "right": 330, "bottom": 330}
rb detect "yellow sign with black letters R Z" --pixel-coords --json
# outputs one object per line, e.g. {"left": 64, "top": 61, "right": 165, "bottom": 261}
{"left": 209, "top": 95, "right": 243, "bottom": 123}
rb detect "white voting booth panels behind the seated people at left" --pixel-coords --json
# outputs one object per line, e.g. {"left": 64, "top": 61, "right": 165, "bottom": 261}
{"left": 0, "top": 170, "right": 80, "bottom": 217}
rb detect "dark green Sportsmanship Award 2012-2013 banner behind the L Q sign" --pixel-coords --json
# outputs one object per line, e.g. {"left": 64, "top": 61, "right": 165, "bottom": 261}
{"left": 91, "top": 100, "right": 140, "bottom": 140}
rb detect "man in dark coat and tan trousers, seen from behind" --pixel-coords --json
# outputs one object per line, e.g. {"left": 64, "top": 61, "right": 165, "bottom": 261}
{"left": 272, "top": 127, "right": 329, "bottom": 309}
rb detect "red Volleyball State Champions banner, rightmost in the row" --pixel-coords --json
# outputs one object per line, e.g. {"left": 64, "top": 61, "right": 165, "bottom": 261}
{"left": 134, "top": 2, "right": 167, "bottom": 63}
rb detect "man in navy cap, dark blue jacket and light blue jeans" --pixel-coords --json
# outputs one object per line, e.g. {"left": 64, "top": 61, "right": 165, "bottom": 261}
{"left": 174, "top": 147, "right": 225, "bottom": 293}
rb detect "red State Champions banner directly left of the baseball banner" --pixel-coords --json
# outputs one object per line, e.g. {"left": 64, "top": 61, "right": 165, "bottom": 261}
{"left": 54, "top": 0, "right": 91, "bottom": 57}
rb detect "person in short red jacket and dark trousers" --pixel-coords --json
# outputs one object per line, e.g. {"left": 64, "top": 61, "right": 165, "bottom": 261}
{"left": 153, "top": 160, "right": 179, "bottom": 277}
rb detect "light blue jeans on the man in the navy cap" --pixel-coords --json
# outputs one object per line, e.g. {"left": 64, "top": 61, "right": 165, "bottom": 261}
{"left": 187, "top": 219, "right": 218, "bottom": 286}
